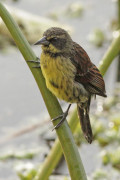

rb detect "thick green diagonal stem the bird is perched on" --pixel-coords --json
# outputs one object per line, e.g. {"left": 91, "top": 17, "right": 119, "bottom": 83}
{"left": 0, "top": 3, "right": 87, "bottom": 180}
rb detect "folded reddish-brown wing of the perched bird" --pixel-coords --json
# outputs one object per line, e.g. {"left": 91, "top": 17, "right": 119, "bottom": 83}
{"left": 71, "top": 43, "right": 106, "bottom": 97}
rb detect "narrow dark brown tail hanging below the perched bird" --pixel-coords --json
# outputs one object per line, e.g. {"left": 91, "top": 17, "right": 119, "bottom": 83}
{"left": 77, "top": 99, "right": 93, "bottom": 144}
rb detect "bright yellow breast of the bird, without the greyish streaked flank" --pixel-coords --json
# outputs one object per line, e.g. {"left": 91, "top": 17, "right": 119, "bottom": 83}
{"left": 40, "top": 52, "right": 76, "bottom": 102}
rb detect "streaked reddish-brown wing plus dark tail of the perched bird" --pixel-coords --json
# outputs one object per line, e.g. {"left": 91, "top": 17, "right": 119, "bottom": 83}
{"left": 71, "top": 42, "right": 107, "bottom": 143}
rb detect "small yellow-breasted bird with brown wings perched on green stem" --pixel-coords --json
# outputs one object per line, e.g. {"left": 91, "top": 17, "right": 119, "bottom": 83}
{"left": 32, "top": 27, "right": 107, "bottom": 143}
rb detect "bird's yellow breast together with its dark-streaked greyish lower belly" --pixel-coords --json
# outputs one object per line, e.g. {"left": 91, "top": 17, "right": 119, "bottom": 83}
{"left": 41, "top": 54, "right": 88, "bottom": 103}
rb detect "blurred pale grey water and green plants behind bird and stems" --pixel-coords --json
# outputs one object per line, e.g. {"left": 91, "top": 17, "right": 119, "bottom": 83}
{"left": 0, "top": 0, "right": 120, "bottom": 180}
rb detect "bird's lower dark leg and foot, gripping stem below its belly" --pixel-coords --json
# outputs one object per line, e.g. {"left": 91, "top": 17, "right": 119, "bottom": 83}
{"left": 51, "top": 104, "right": 71, "bottom": 131}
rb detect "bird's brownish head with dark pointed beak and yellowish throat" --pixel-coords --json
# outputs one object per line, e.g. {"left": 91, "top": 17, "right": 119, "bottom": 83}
{"left": 35, "top": 27, "right": 72, "bottom": 53}
